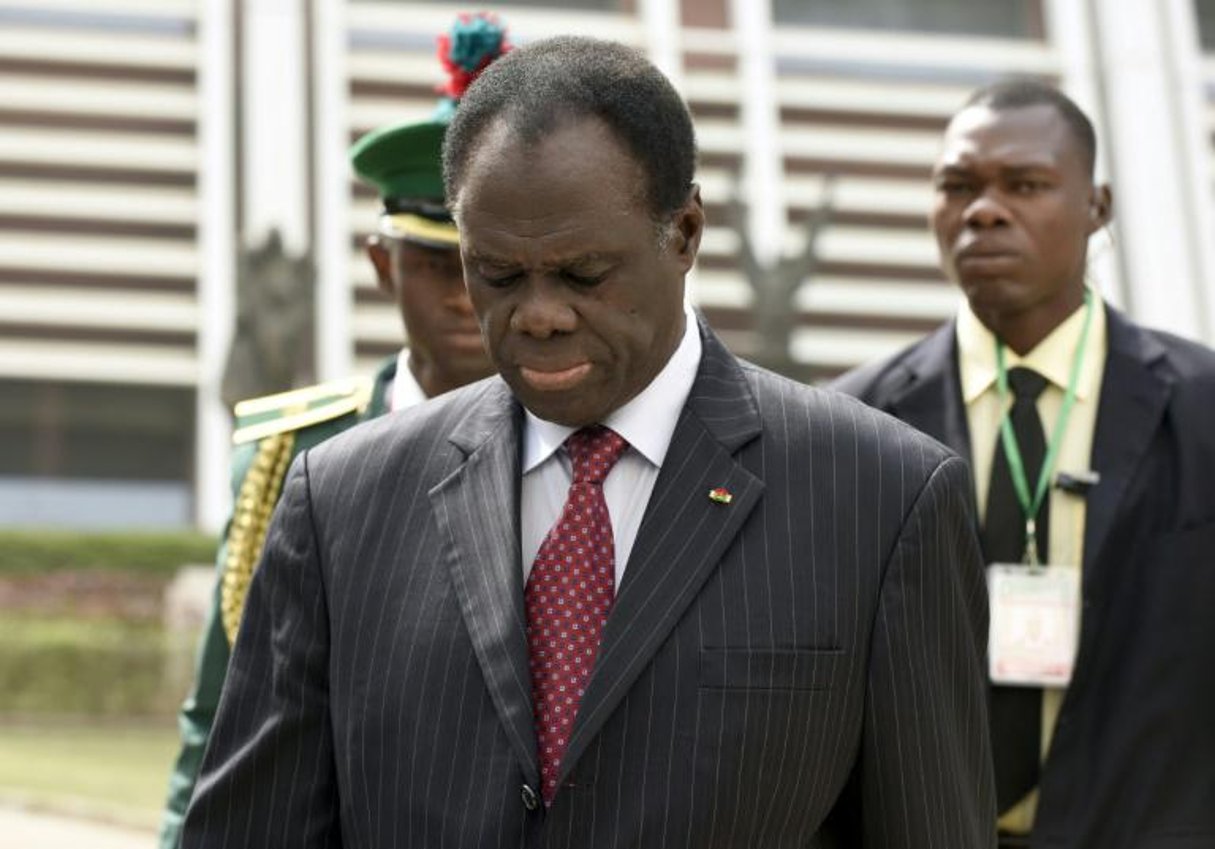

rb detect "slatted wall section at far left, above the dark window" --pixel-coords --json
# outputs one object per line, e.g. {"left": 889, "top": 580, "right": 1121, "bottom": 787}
{"left": 0, "top": 0, "right": 198, "bottom": 386}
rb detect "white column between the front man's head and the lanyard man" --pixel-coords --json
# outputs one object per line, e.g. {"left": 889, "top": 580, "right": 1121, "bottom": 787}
{"left": 730, "top": 0, "right": 786, "bottom": 265}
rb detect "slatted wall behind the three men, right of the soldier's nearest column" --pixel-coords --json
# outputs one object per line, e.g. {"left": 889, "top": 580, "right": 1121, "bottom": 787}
{"left": 350, "top": 0, "right": 1056, "bottom": 379}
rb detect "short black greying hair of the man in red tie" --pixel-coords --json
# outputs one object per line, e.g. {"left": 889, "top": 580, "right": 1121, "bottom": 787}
{"left": 443, "top": 36, "right": 696, "bottom": 221}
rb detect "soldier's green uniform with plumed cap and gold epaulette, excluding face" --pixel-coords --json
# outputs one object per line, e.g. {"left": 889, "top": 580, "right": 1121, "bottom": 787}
{"left": 159, "top": 13, "right": 509, "bottom": 849}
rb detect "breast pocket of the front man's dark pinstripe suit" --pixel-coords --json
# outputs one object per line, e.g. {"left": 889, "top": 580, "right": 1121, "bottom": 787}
{"left": 699, "top": 649, "right": 844, "bottom": 691}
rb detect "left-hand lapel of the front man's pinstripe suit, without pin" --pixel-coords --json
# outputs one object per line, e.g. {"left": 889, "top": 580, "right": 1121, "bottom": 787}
{"left": 430, "top": 381, "right": 539, "bottom": 786}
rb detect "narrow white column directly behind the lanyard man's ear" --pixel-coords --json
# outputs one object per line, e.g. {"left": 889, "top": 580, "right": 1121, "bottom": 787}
{"left": 1045, "top": 0, "right": 1128, "bottom": 306}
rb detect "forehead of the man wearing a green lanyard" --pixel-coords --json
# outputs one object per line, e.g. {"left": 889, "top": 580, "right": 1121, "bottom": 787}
{"left": 937, "top": 104, "right": 1079, "bottom": 170}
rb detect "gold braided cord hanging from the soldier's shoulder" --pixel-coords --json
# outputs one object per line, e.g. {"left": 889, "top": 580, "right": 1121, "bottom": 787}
{"left": 220, "top": 432, "right": 295, "bottom": 645}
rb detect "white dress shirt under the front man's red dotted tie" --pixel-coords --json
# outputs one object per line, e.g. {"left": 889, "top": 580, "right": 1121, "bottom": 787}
{"left": 520, "top": 305, "right": 701, "bottom": 588}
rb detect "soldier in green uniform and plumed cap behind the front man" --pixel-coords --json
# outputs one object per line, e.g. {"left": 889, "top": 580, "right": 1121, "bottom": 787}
{"left": 159, "top": 13, "right": 509, "bottom": 849}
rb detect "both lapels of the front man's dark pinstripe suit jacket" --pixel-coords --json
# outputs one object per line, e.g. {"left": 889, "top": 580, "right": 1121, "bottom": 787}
{"left": 430, "top": 319, "right": 763, "bottom": 786}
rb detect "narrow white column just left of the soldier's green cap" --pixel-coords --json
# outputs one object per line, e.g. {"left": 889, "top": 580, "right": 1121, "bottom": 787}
{"left": 312, "top": 0, "right": 354, "bottom": 380}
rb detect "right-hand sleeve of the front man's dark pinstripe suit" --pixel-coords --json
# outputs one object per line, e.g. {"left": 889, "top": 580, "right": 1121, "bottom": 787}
{"left": 858, "top": 457, "right": 995, "bottom": 849}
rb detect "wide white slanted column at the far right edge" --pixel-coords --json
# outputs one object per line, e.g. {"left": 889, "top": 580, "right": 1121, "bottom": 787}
{"left": 1091, "top": 0, "right": 1215, "bottom": 340}
